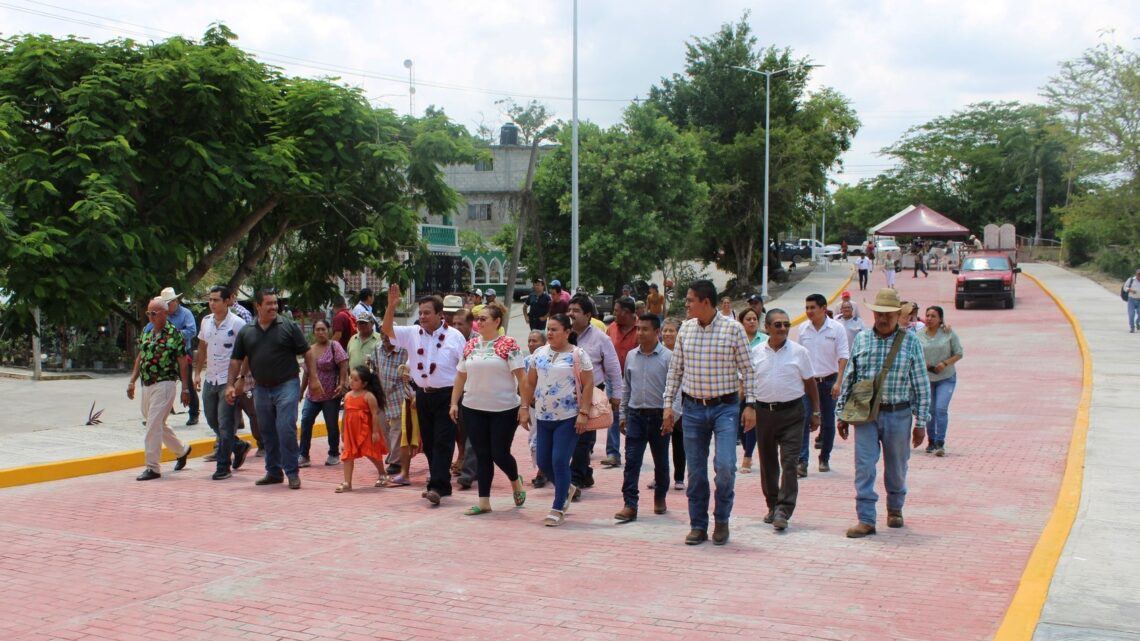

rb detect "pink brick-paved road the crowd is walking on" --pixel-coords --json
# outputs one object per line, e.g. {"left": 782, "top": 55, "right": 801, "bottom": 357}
{"left": 0, "top": 273, "right": 1081, "bottom": 641}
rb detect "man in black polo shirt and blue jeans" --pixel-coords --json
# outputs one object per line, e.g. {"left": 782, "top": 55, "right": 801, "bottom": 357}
{"left": 226, "top": 290, "right": 325, "bottom": 489}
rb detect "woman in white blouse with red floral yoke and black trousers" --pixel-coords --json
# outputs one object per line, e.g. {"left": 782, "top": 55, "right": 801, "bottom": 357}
{"left": 450, "top": 302, "right": 530, "bottom": 516}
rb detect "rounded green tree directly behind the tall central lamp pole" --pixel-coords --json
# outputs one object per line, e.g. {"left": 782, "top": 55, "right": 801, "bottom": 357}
{"left": 523, "top": 105, "right": 707, "bottom": 291}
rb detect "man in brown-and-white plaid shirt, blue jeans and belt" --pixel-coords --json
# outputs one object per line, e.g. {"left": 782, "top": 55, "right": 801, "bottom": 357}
{"left": 662, "top": 281, "right": 756, "bottom": 545}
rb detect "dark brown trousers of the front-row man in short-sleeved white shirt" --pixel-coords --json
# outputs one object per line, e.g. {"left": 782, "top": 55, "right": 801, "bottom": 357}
{"left": 756, "top": 403, "right": 804, "bottom": 518}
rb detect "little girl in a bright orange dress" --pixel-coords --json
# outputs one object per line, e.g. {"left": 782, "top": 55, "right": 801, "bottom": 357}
{"left": 336, "top": 366, "right": 388, "bottom": 494}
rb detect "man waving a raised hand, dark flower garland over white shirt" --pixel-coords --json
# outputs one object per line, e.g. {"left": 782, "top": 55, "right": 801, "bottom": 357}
{"left": 381, "top": 283, "right": 465, "bottom": 505}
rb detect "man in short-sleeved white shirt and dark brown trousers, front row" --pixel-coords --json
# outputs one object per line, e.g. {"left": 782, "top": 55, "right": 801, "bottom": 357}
{"left": 752, "top": 309, "right": 820, "bottom": 530}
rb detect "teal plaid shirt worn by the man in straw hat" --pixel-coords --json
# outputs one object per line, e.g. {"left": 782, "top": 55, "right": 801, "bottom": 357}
{"left": 836, "top": 327, "right": 930, "bottom": 427}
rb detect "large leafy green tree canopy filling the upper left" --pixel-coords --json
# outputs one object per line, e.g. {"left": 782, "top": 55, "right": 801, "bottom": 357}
{"left": 0, "top": 25, "right": 475, "bottom": 323}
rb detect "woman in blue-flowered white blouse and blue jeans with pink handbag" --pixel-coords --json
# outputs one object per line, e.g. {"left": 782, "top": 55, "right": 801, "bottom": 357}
{"left": 522, "top": 314, "right": 594, "bottom": 526}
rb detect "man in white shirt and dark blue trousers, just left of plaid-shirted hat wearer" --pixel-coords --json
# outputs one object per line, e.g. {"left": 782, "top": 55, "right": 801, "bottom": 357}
{"left": 796, "top": 294, "right": 850, "bottom": 478}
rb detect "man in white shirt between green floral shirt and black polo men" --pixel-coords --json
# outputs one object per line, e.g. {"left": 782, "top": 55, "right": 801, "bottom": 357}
{"left": 194, "top": 286, "right": 250, "bottom": 480}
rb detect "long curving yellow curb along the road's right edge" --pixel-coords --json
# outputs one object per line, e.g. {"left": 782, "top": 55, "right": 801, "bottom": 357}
{"left": 994, "top": 271, "right": 1092, "bottom": 641}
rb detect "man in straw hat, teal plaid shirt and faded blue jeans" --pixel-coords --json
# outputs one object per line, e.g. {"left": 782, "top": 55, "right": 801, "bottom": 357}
{"left": 834, "top": 289, "right": 930, "bottom": 538}
